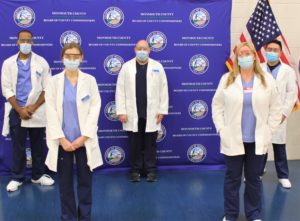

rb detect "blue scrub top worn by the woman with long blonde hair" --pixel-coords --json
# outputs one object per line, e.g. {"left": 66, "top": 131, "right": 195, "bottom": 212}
{"left": 242, "top": 78, "right": 256, "bottom": 143}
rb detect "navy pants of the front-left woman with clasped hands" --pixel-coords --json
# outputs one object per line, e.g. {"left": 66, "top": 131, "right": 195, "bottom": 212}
{"left": 57, "top": 147, "right": 92, "bottom": 221}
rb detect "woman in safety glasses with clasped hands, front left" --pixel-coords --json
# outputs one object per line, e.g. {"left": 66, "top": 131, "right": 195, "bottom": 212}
{"left": 45, "top": 42, "right": 103, "bottom": 221}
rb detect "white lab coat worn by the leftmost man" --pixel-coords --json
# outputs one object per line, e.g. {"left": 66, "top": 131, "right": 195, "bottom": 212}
{"left": 1, "top": 52, "right": 51, "bottom": 136}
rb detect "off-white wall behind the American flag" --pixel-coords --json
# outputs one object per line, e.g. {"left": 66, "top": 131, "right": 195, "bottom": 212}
{"left": 231, "top": 0, "right": 300, "bottom": 159}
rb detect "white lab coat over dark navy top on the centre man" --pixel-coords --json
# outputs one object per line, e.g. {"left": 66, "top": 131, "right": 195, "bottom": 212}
{"left": 116, "top": 58, "right": 169, "bottom": 132}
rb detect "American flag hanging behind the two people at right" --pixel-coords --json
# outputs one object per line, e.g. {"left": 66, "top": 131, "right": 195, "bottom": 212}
{"left": 226, "top": 0, "right": 300, "bottom": 109}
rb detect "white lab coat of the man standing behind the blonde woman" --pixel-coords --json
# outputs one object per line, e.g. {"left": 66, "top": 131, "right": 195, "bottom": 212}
{"left": 263, "top": 63, "right": 298, "bottom": 144}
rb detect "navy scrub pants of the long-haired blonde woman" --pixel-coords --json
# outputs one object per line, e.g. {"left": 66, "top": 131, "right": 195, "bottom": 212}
{"left": 224, "top": 143, "right": 264, "bottom": 221}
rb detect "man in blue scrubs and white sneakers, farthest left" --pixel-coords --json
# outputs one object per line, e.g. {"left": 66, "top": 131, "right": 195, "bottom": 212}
{"left": 1, "top": 30, "right": 54, "bottom": 192}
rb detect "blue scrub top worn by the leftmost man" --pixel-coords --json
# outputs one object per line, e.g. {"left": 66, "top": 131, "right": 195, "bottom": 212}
{"left": 16, "top": 57, "right": 32, "bottom": 107}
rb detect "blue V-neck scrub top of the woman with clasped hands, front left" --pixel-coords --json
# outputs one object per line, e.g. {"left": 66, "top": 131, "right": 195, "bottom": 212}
{"left": 62, "top": 77, "right": 81, "bottom": 142}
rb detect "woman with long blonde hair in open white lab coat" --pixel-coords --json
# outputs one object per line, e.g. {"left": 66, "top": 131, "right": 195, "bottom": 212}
{"left": 212, "top": 42, "right": 281, "bottom": 221}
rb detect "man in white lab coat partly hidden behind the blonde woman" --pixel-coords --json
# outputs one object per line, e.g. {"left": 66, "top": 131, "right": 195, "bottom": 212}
{"left": 263, "top": 40, "right": 298, "bottom": 188}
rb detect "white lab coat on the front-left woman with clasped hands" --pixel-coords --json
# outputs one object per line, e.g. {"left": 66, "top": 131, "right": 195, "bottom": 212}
{"left": 45, "top": 71, "right": 103, "bottom": 172}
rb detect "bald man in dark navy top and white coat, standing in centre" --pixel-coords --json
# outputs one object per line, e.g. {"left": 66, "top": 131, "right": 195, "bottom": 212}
{"left": 116, "top": 40, "right": 169, "bottom": 182}
